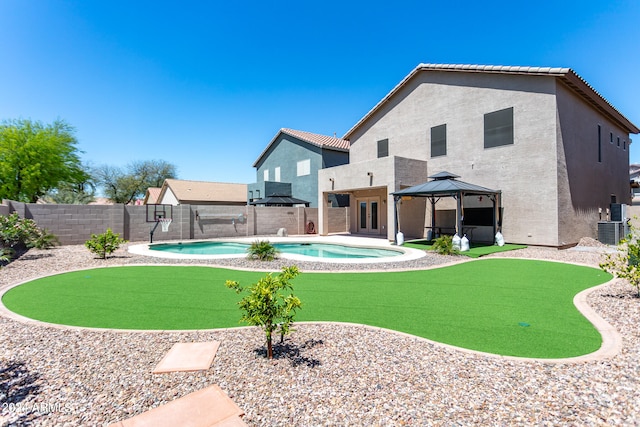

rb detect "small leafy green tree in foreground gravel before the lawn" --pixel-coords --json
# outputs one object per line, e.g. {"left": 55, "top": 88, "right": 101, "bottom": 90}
{"left": 226, "top": 265, "right": 302, "bottom": 359}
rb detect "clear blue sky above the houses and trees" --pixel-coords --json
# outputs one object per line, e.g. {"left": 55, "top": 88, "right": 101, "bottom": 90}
{"left": 0, "top": 0, "right": 640, "bottom": 183}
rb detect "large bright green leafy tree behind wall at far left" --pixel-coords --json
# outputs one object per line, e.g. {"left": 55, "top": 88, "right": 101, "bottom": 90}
{"left": 0, "top": 120, "right": 89, "bottom": 203}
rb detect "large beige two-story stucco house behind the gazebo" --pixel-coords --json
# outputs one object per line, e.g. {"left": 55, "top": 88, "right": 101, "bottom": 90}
{"left": 318, "top": 64, "right": 639, "bottom": 247}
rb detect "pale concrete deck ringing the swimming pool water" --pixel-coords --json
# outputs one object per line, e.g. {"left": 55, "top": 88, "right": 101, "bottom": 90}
{"left": 129, "top": 235, "right": 426, "bottom": 264}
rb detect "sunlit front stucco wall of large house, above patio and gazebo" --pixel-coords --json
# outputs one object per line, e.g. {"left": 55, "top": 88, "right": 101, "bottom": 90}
{"left": 341, "top": 72, "right": 558, "bottom": 246}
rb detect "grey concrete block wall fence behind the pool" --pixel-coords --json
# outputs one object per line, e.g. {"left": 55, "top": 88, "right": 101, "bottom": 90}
{"left": 0, "top": 200, "right": 349, "bottom": 245}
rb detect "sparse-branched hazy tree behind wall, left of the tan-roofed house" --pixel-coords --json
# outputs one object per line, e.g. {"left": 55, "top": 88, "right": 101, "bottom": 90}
{"left": 94, "top": 160, "right": 177, "bottom": 204}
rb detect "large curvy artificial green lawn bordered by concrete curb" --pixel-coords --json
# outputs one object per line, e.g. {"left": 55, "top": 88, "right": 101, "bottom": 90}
{"left": 2, "top": 259, "right": 611, "bottom": 358}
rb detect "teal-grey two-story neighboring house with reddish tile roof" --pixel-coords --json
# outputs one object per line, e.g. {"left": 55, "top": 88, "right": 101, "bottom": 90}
{"left": 248, "top": 129, "right": 349, "bottom": 207}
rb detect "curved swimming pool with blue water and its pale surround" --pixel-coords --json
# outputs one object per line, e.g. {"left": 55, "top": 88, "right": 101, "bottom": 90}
{"left": 129, "top": 236, "right": 425, "bottom": 263}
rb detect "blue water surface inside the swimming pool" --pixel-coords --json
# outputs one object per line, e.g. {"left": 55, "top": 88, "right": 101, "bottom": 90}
{"left": 149, "top": 242, "right": 403, "bottom": 259}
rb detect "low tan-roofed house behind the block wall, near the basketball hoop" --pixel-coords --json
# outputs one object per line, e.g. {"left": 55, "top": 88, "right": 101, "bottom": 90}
{"left": 157, "top": 179, "right": 247, "bottom": 203}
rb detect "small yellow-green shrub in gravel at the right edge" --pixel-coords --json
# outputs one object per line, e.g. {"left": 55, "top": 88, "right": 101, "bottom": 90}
{"left": 600, "top": 221, "right": 640, "bottom": 298}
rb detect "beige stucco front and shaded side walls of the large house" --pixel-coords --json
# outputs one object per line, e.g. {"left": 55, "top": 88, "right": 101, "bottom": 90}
{"left": 336, "top": 67, "right": 630, "bottom": 246}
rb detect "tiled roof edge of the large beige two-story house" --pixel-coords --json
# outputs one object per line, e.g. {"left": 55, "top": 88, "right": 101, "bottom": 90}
{"left": 343, "top": 64, "right": 640, "bottom": 139}
